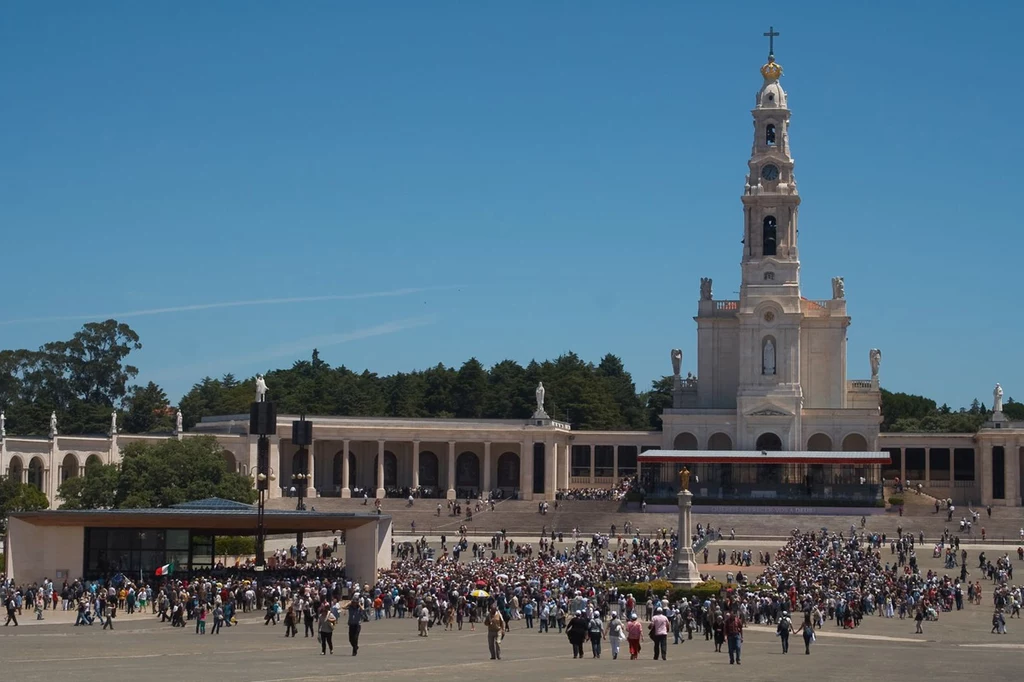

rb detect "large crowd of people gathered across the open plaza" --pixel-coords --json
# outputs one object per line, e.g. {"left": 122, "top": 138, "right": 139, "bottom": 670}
{"left": 0, "top": 509, "right": 1024, "bottom": 665}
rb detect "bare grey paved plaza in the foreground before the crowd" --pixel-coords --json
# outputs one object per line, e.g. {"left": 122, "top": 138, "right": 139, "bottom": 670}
{"left": 0, "top": 541, "right": 1024, "bottom": 682}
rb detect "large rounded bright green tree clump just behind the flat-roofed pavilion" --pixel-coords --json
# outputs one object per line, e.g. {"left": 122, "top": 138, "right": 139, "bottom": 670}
{"left": 58, "top": 436, "right": 257, "bottom": 509}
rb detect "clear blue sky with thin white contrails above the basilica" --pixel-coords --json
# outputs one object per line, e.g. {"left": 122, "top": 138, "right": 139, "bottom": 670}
{"left": 0, "top": 0, "right": 1024, "bottom": 406}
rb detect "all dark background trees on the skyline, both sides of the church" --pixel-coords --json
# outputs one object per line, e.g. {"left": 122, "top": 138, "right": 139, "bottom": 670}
{"left": 0, "top": 319, "right": 1024, "bottom": 435}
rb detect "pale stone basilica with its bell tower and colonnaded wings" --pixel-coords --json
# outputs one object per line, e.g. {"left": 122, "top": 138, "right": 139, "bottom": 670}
{"left": 0, "top": 49, "right": 1024, "bottom": 506}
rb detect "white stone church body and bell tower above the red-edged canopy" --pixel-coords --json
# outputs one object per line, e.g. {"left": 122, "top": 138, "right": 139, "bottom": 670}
{"left": 663, "top": 53, "right": 881, "bottom": 451}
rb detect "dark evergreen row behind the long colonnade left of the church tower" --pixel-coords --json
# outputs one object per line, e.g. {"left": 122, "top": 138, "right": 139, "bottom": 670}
{"left": 181, "top": 350, "right": 655, "bottom": 429}
